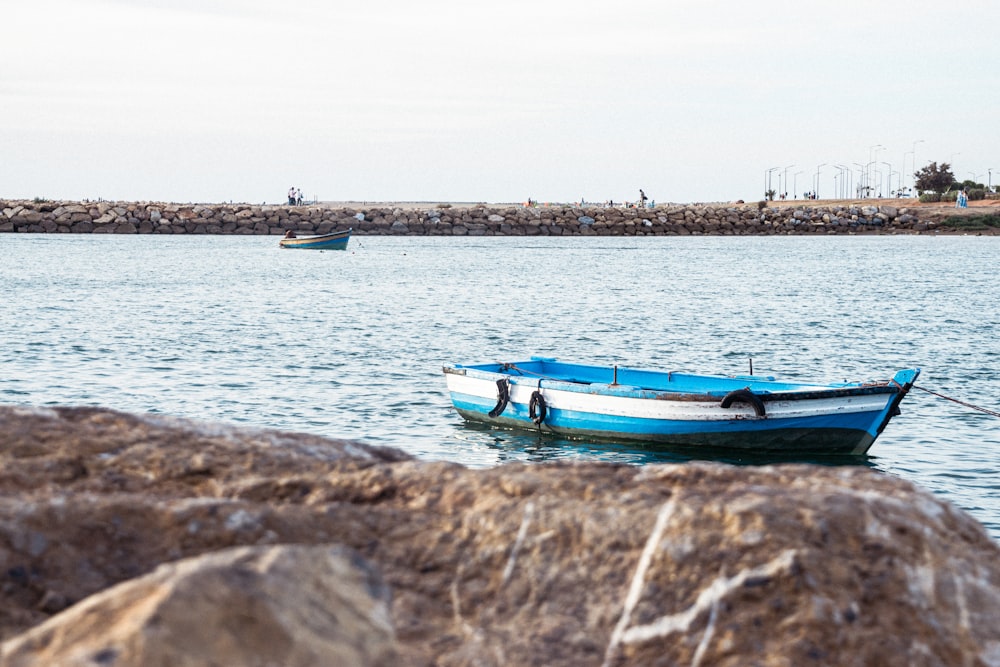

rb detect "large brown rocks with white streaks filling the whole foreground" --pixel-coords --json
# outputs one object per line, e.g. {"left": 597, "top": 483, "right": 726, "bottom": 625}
{"left": 0, "top": 406, "right": 1000, "bottom": 667}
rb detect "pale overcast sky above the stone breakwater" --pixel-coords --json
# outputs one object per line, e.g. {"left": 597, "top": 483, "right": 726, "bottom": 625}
{"left": 0, "top": 0, "right": 1000, "bottom": 203}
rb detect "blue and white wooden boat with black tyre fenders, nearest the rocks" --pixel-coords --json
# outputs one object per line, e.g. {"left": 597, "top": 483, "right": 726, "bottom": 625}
{"left": 444, "top": 357, "right": 920, "bottom": 454}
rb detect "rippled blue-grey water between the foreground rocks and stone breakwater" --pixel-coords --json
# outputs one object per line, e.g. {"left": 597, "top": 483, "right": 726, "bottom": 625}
{"left": 0, "top": 234, "right": 1000, "bottom": 538}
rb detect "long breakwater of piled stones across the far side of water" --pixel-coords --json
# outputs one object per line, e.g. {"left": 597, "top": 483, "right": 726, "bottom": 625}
{"left": 0, "top": 200, "right": 946, "bottom": 236}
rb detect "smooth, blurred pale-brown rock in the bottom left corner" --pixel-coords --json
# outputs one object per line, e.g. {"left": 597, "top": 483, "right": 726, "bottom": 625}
{"left": 3, "top": 546, "right": 398, "bottom": 667}
